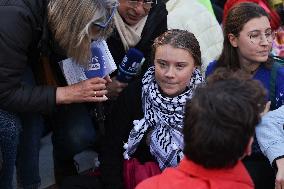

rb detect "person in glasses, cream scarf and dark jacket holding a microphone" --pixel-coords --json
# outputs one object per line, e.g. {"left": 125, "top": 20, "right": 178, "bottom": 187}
{"left": 107, "top": 0, "right": 167, "bottom": 99}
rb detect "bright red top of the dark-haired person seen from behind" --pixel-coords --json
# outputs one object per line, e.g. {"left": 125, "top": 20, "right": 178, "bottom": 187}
{"left": 136, "top": 159, "right": 254, "bottom": 189}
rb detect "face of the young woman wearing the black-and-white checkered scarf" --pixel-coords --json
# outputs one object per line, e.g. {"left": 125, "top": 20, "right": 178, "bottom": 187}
{"left": 154, "top": 45, "right": 195, "bottom": 97}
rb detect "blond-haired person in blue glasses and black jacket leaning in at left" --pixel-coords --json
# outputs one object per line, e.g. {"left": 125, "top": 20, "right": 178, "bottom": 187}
{"left": 0, "top": 0, "right": 118, "bottom": 189}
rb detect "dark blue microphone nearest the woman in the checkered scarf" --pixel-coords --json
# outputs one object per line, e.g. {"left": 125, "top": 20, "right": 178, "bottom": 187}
{"left": 116, "top": 48, "right": 145, "bottom": 83}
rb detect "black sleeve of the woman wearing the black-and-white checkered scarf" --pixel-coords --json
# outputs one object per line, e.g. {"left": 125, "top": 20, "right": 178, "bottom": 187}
{"left": 99, "top": 80, "right": 143, "bottom": 189}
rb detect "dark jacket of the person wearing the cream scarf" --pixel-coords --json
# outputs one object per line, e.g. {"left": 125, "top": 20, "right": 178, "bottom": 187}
{"left": 107, "top": 3, "right": 168, "bottom": 77}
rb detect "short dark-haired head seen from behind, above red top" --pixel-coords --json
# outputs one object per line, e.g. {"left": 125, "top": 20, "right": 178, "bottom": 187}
{"left": 184, "top": 68, "right": 265, "bottom": 169}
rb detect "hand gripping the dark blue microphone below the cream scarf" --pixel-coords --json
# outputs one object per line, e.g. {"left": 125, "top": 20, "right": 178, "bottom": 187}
{"left": 107, "top": 77, "right": 128, "bottom": 99}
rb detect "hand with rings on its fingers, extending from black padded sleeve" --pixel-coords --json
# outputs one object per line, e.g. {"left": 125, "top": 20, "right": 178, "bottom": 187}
{"left": 56, "top": 77, "right": 111, "bottom": 104}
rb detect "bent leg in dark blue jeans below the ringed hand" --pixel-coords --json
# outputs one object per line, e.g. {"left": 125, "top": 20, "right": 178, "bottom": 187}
{"left": 52, "top": 104, "right": 95, "bottom": 182}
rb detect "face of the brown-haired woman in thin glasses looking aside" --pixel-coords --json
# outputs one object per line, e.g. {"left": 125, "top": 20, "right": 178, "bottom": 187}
{"left": 230, "top": 16, "right": 273, "bottom": 63}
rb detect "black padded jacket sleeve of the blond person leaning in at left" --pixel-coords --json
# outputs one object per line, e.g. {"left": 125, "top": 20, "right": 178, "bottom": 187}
{"left": 0, "top": 5, "right": 56, "bottom": 112}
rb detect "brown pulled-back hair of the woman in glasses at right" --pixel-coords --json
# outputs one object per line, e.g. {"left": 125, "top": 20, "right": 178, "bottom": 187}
{"left": 217, "top": 2, "right": 271, "bottom": 70}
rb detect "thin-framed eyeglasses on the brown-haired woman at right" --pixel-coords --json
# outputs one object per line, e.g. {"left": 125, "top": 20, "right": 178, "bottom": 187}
{"left": 248, "top": 30, "right": 275, "bottom": 44}
